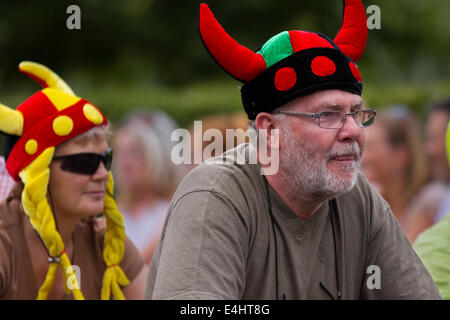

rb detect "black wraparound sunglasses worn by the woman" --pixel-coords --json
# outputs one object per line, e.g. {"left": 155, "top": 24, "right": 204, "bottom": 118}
{"left": 53, "top": 149, "right": 113, "bottom": 175}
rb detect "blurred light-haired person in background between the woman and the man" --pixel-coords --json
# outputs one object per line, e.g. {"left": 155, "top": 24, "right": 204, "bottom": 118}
{"left": 113, "top": 111, "right": 185, "bottom": 264}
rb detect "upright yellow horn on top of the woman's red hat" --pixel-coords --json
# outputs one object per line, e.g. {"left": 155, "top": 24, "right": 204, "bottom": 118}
{"left": 19, "top": 61, "right": 75, "bottom": 96}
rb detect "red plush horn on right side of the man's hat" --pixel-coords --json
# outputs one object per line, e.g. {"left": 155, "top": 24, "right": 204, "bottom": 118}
{"left": 334, "top": 0, "right": 367, "bottom": 62}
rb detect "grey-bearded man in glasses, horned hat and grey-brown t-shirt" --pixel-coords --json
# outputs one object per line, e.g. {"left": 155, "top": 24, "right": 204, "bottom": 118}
{"left": 145, "top": 0, "right": 440, "bottom": 300}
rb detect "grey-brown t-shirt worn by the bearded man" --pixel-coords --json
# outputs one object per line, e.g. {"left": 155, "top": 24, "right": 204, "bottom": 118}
{"left": 145, "top": 145, "right": 440, "bottom": 299}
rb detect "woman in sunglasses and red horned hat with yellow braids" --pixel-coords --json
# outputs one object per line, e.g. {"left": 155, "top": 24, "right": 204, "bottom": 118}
{"left": 0, "top": 62, "right": 147, "bottom": 300}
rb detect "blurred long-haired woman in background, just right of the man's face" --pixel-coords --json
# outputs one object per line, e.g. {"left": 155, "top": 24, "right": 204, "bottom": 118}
{"left": 361, "top": 106, "right": 432, "bottom": 242}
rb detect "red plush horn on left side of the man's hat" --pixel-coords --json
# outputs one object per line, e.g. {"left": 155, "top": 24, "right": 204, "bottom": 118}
{"left": 199, "top": 3, "right": 266, "bottom": 82}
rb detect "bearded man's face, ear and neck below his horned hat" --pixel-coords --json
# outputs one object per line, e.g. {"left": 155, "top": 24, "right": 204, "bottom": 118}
{"left": 272, "top": 90, "right": 368, "bottom": 219}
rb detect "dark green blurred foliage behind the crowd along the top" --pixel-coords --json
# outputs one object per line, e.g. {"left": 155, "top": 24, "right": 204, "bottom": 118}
{"left": 0, "top": 0, "right": 450, "bottom": 126}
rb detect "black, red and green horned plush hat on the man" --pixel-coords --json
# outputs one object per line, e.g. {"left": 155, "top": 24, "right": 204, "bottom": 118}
{"left": 199, "top": 0, "right": 367, "bottom": 120}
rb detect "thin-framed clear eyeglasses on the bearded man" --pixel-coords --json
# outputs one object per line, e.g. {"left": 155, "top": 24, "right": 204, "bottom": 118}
{"left": 278, "top": 109, "right": 377, "bottom": 129}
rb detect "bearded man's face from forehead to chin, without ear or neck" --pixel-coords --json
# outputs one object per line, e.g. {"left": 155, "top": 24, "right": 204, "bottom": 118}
{"left": 280, "top": 90, "right": 364, "bottom": 197}
